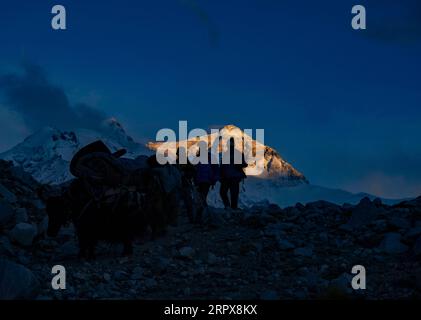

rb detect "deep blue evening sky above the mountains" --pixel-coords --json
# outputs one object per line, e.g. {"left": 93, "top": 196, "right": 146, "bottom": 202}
{"left": 0, "top": 0, "right": 421, "bottom": 197}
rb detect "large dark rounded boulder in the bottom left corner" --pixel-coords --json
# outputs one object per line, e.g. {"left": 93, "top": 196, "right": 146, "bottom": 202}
{"left": 0, "top": 258, "right": 39, "bottom": 300}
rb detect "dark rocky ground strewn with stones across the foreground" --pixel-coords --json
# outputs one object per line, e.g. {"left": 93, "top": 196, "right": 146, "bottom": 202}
{"left": 0, "top": 162, "right": 421, "bottom": 299}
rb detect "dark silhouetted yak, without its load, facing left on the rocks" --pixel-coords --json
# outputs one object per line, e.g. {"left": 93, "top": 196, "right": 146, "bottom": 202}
{"left": 46, "top": 172, "right": 168, "bottom": 259}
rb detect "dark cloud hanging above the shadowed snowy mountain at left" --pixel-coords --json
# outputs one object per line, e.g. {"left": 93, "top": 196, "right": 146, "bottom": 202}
{"left": 0, "top": 63, "right": 106, "bottom": 131}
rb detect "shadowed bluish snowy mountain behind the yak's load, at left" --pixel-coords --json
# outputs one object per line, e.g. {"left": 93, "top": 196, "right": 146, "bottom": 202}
{"left": 0, "top": 118, "right": 150, "bottom": 184}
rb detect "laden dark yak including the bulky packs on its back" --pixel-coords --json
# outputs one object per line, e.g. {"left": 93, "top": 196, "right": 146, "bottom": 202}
{"left": 46, "top": 141, "right": 201, "bottom": 258}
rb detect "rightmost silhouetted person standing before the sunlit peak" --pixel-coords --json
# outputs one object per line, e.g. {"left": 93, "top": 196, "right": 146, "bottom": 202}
{"left": 219, "top": 138, "right": 247, "bottom": 209}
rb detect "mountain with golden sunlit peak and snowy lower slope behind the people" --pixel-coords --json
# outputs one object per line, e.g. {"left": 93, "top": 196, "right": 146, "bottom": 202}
{"left": 148, "top": 125, "right": 390, "bottom": 207}
